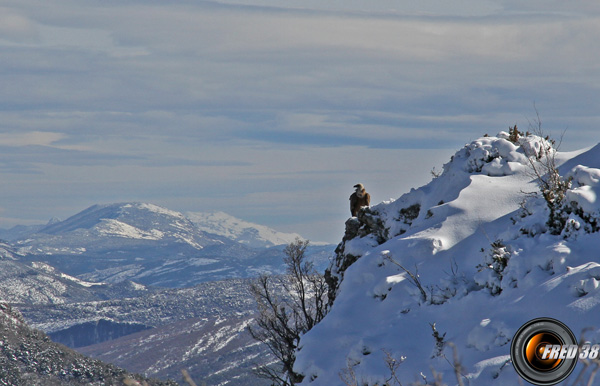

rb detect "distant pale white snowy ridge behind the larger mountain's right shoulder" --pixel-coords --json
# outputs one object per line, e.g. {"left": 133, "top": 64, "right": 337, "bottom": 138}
{"left": 186, "top": 212, "right": 302, "bottom": 248}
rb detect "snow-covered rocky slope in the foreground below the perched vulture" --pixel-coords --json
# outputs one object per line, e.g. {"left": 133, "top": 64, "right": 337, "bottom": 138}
{"left": 295, "top": 133, "right": 600, "bottom": 386}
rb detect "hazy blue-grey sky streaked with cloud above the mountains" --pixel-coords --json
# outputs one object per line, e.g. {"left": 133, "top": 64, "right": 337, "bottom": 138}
{"left": 0, "top": 0, "right": 600, "bottom": 243}
